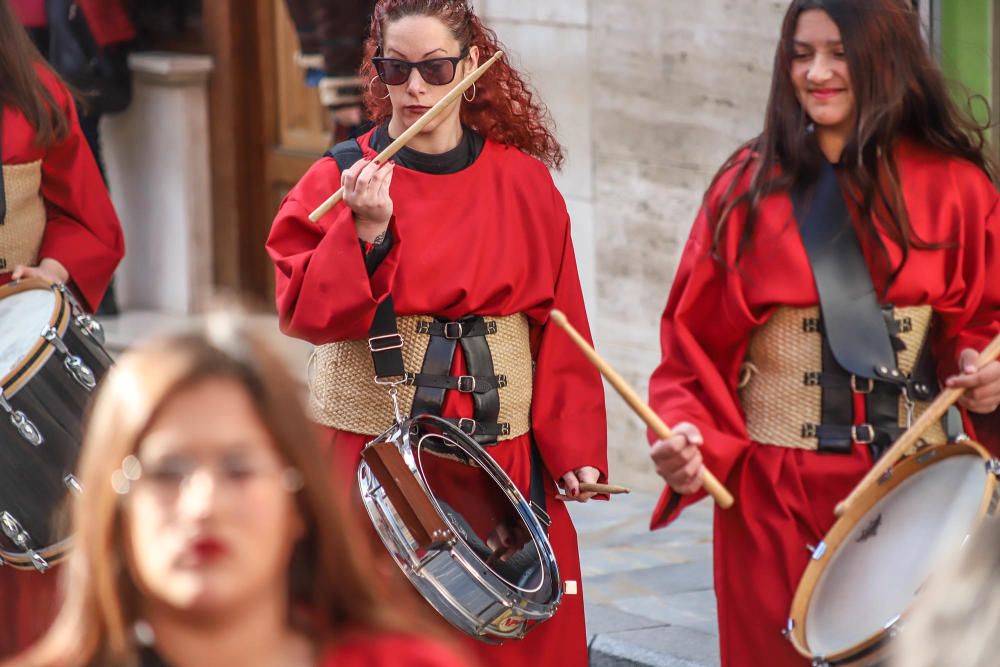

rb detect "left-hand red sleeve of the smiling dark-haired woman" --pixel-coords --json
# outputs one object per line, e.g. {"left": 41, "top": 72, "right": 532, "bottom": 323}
{"left": 649, "top": 190, "right": 752, "bottom": 528}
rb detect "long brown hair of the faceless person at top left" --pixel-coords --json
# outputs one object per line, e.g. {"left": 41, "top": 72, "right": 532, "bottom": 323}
{"left": 0, "top": 0, "right": 69, "bottom": 146}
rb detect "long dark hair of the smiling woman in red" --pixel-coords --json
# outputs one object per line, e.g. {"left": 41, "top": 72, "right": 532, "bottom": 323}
{"left": 706, "top": 0, "right": 998, "bottom": 285}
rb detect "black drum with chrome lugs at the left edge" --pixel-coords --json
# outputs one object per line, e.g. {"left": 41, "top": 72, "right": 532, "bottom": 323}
{"left": 0, "top": 279, "right": 111, "bottom": 572}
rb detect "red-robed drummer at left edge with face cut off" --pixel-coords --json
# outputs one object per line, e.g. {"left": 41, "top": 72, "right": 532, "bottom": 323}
{"left": 0, "top": 0, "right": 124, "bottom": 656}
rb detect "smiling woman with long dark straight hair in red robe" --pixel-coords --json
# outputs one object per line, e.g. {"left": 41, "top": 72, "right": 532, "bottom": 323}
{"left": 650, "top": 0, "right": 1000, "bottom": 665}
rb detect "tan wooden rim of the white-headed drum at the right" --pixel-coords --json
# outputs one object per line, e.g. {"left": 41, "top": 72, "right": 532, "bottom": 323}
{"left": 786, "top": 439, "right": 997, "bottom": 664}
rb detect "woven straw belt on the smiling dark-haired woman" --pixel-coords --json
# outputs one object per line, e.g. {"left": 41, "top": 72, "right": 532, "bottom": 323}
{"left": 739, "top": 306, "right": 947, "bottom": 449}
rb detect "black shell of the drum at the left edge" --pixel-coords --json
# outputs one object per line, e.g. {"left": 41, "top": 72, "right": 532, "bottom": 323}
{"left": 0, "top": 284, "right": 112, "bottom": 569}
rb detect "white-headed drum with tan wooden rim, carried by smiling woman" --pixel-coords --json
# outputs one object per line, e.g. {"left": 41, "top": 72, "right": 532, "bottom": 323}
{"left": 785, "top": 440, "right": 1000, "bottom": 666}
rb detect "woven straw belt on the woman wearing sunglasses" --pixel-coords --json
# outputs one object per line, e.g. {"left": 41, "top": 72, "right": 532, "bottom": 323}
{"left": 309, "top": 313, "right": 532, "bottom": 440}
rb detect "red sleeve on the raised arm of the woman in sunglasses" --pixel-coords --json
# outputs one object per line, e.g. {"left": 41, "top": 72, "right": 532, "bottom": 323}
{"left": 267, "top": 158, "right": 403, "bottom": 345}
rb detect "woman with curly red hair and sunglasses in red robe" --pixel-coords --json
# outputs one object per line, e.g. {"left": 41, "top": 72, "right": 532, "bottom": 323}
{"left": 267, "top": 0, "right": 607, "bottom": 665}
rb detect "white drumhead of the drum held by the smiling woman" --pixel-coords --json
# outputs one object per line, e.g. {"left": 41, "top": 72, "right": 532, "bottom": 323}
{"left": 804, "top": 445, "right": 987, "bottom": 656}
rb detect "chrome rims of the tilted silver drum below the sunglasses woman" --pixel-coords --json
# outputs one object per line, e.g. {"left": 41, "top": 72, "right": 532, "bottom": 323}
{"left": 358, "top": 414, "right": 562, "bottom": 641}
